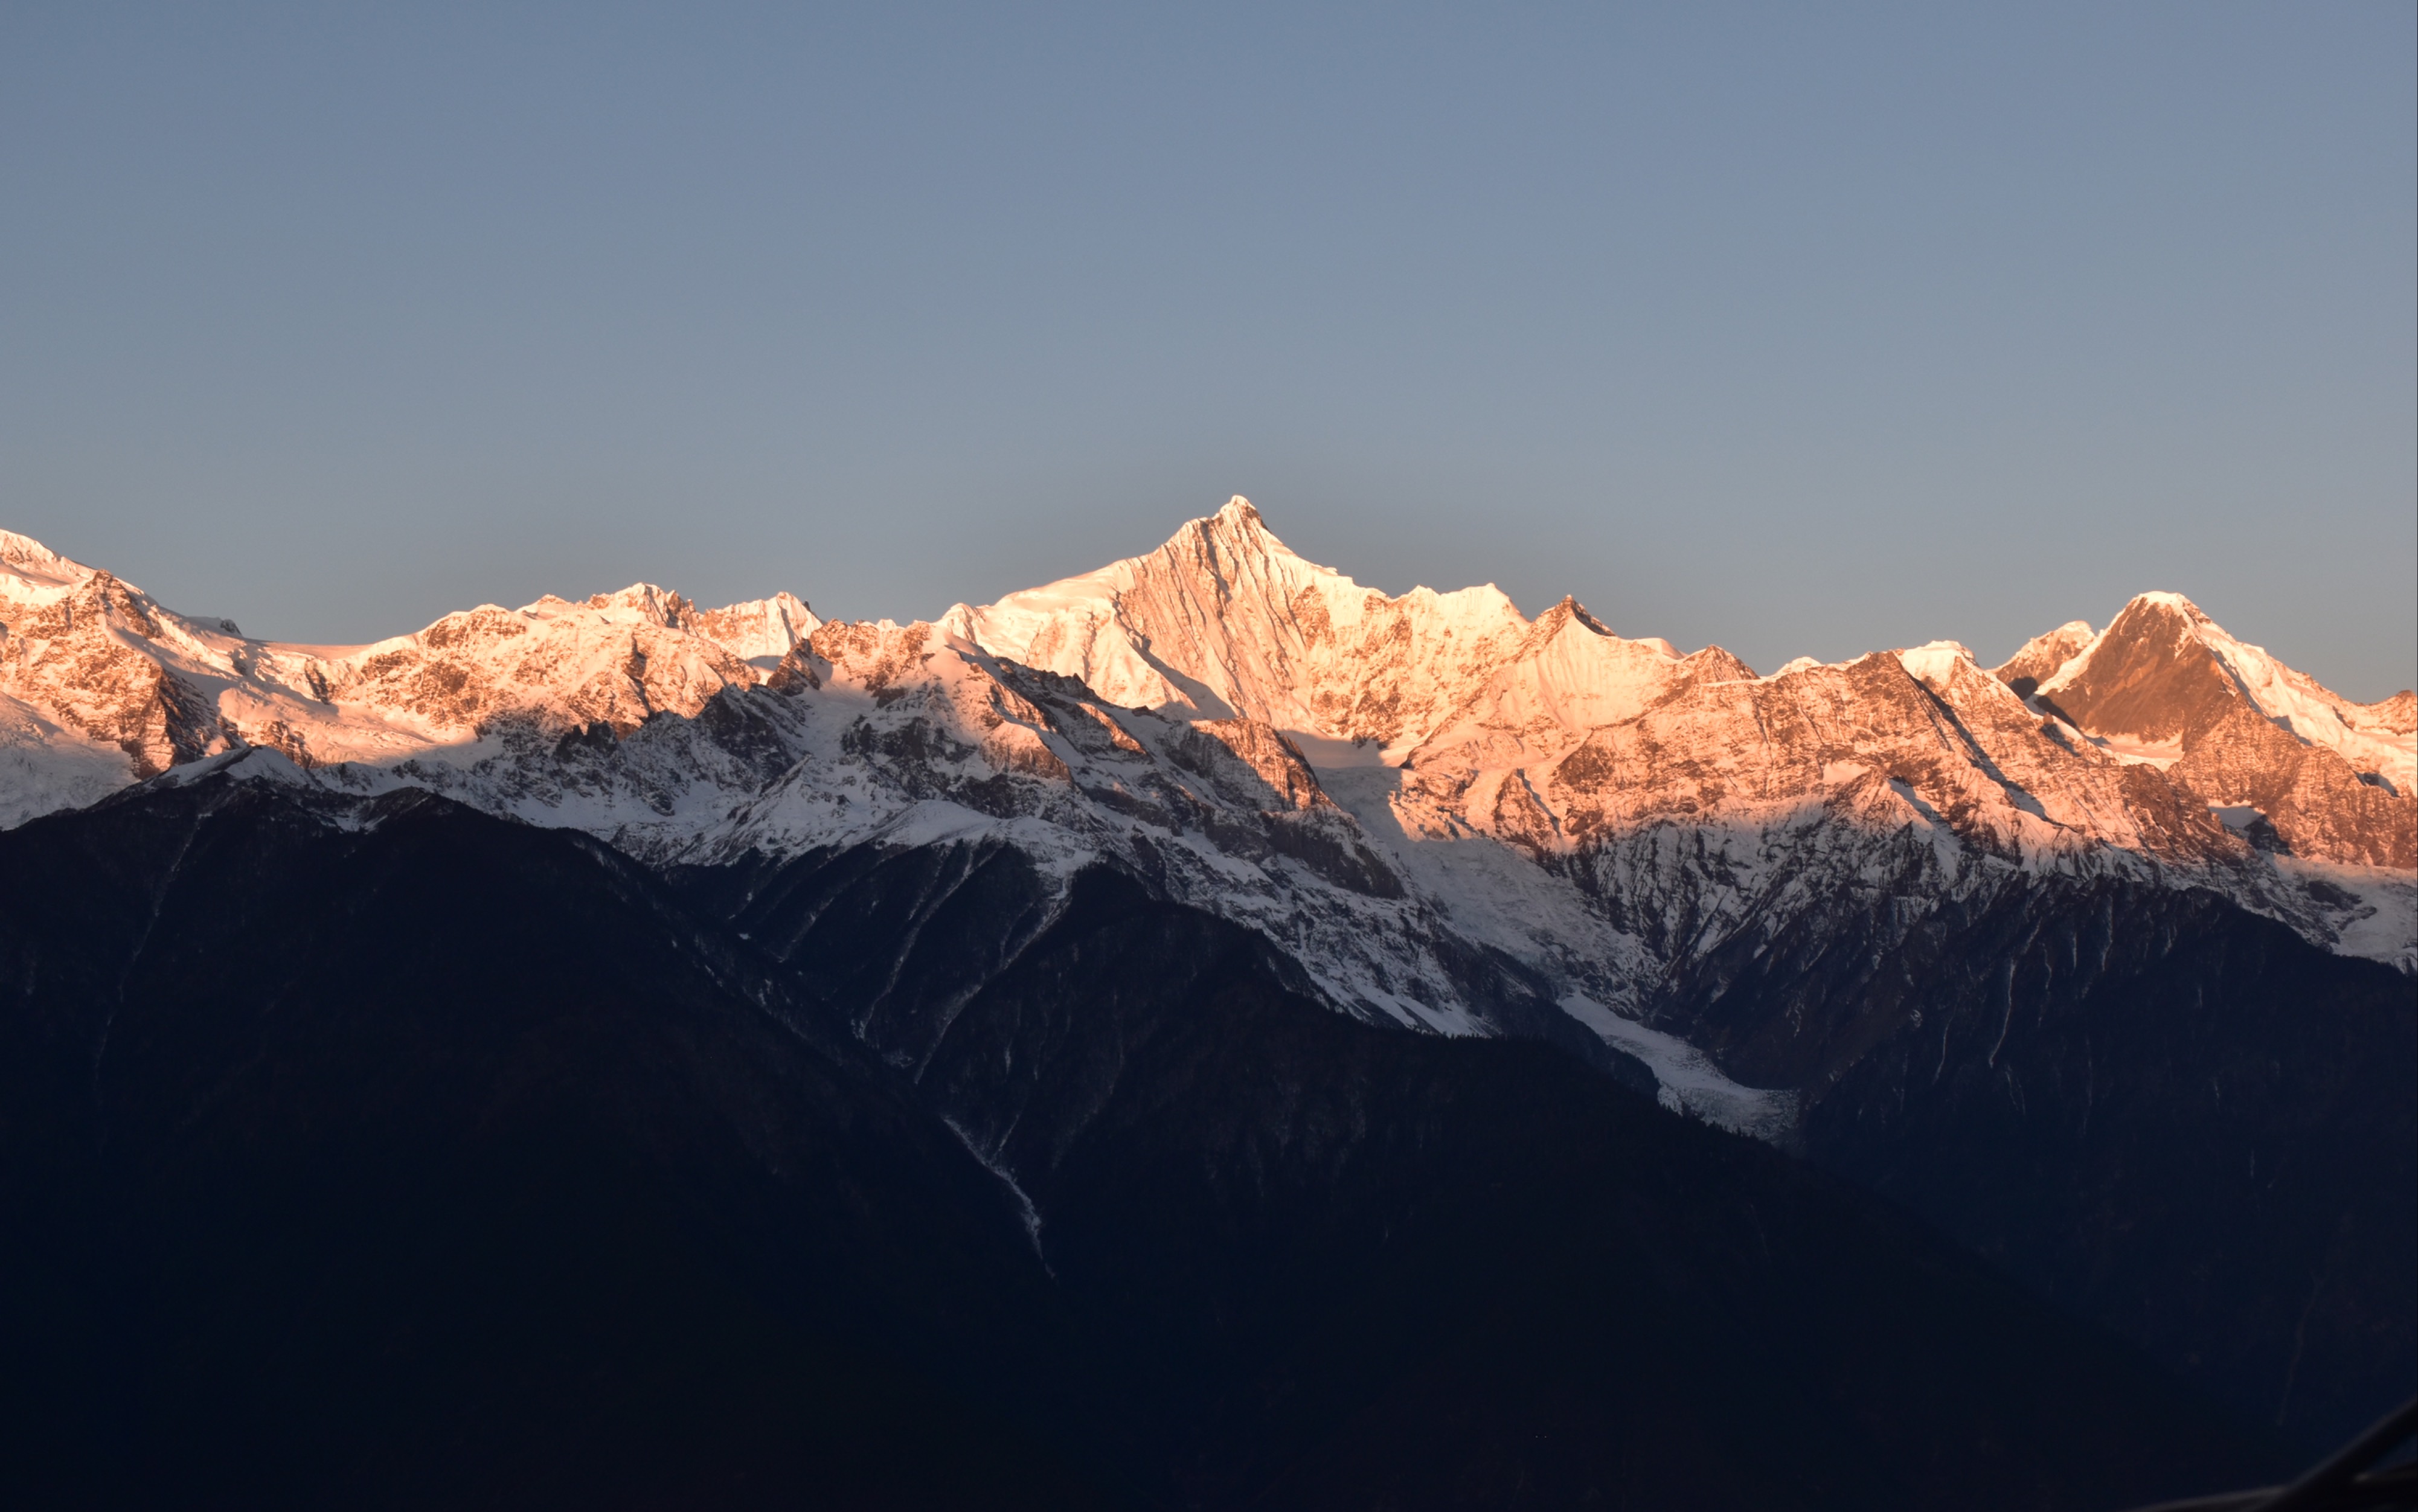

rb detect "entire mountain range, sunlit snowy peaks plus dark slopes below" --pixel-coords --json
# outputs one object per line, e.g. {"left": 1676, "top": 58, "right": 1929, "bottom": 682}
{"left": 0, "top": 498, "right": 2418, "bottom": 1507}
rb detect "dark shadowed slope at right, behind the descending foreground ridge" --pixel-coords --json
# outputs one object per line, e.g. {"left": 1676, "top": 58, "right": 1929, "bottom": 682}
{"left": 1666, "top": 878, "right": 2418, "bottom": 1454}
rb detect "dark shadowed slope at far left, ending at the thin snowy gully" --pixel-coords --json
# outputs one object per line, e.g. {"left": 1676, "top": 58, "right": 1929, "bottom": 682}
{"left": 0, "top": 781, "right": 1100, "bottom": 1507}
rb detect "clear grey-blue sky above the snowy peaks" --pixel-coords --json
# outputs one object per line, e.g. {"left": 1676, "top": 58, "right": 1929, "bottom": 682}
{"left": 0, "top": 0, "right": 2418, "bottom": 699}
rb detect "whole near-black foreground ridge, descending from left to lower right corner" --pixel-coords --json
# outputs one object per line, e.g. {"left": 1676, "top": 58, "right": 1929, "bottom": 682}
{"left": 0, "top": 779, "right": 2295, "bottom": 1510}
